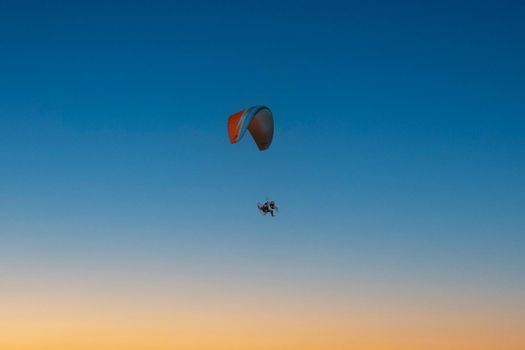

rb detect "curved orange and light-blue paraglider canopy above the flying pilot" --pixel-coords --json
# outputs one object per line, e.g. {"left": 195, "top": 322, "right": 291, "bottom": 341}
{"left": 228, "top": 106, "right": 273, "bottom": 151}
